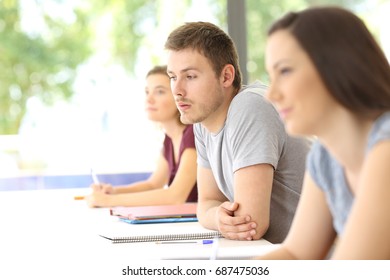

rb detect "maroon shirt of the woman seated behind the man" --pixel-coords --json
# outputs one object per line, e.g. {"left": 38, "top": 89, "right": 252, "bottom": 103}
{"left": 163, "top": 124, "right": 198, "bottom": 202}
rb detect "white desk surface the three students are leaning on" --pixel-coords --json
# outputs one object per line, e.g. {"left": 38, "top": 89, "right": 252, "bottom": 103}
{"left": 0, "top": 188, "right": 274, "bottom": 279}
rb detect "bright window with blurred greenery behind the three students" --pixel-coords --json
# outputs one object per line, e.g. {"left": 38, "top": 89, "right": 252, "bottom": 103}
{"left": 0, "top": 0, "right": 390, "bottom": 185}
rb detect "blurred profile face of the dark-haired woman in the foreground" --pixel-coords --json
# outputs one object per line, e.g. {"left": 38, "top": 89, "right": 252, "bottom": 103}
{"left": 265, "top": 30, "right": 338, "bottom": 135}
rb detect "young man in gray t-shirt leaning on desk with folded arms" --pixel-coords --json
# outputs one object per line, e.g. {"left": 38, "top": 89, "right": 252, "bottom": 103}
{"left": 165, "top": 22, "right": 309, "bottom": 243}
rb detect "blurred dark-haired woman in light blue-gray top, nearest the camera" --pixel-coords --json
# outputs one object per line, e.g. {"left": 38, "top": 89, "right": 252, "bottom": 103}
{"left": 260, "top": 7, "right": 390, "bottom": 259}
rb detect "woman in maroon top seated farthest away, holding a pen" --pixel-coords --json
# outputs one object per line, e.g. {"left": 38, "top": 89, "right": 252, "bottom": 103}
{"left": 86, "top": 66, "right": 198, "bottom": 207}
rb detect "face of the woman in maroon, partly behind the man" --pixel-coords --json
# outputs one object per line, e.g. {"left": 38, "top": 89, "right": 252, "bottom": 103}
{"left": 145, "top": 74, "right": 178, "bottom": 122}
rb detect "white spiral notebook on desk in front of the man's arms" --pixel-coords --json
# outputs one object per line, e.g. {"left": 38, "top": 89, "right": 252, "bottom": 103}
{"left": 99, "top": 222, "right": 222, "bottom": 243}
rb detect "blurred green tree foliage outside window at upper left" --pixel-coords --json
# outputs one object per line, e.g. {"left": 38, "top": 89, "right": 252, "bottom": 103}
{"left": 0, "top": 0, "right": 156, "bottom": 134}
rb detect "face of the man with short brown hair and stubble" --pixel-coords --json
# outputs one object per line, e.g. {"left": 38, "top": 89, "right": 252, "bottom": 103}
{"left": 167, "top": 49, "right": 224, "bottom": 126}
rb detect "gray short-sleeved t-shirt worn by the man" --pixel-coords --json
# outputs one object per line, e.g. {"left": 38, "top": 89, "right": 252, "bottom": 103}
{"left": 194, "top": 82, "right": 310, "bottom": 243}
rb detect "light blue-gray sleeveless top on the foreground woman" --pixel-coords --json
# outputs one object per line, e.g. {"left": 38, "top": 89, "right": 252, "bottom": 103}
{"left": 307, "top": 112, "right": 390, "bottom": 235}
